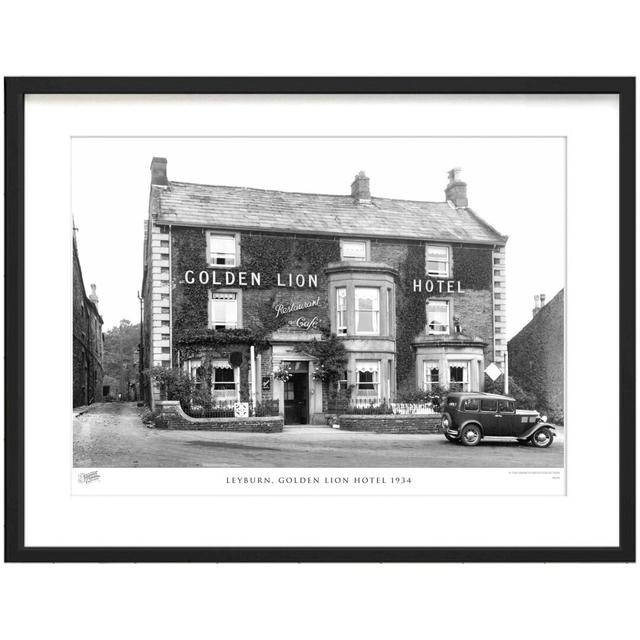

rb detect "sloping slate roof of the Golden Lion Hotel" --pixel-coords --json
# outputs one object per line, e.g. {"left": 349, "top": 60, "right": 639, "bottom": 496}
{"left": 152, "top": 181, "right": 507, "bottom": 244}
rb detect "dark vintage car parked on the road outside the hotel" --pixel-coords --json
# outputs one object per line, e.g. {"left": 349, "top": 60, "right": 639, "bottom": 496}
{"left": 440, "top": 392, "right": 556, "bottom": 448}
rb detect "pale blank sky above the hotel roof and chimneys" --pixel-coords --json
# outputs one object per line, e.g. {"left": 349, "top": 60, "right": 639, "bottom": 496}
{"left": 71, "top": 137, "right": 565, "bottom": 338}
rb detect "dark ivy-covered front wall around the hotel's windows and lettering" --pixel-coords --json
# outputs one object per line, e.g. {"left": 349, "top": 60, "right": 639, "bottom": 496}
{"left": 171, "top": 227, "right": 493, "bottom": 391}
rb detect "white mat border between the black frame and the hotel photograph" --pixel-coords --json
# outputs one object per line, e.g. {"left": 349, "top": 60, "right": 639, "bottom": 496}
{"left": 25, "top": 95, "right": 600, "bottom": 546}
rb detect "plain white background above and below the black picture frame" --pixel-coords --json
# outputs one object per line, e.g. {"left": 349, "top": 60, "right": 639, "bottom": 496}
{"left": 0, "top": 2, "right": 639, "bottom": 639}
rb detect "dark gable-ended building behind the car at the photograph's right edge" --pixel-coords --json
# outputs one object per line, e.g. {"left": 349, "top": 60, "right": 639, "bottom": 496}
{"left": 508, "top": 289, "right": 564, "bottom": 424}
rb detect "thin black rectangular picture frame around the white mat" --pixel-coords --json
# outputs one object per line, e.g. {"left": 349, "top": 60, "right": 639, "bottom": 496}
{"left": 4, "top": 77, "right": 636, "bottom": 562}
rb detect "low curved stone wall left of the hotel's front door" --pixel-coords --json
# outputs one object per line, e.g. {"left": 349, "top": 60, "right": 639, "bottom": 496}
{"left": 154, "top": 400, "right": 284, "bottom": 433}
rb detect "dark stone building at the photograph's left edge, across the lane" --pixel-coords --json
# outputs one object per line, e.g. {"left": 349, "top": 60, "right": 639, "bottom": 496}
{"left": 73, "top": 231, "right": 104, "bottom": 407}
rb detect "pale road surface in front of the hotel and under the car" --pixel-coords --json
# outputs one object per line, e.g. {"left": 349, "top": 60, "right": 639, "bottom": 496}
{"left": 73, "top": 402, "right": 564, "bottom": 468}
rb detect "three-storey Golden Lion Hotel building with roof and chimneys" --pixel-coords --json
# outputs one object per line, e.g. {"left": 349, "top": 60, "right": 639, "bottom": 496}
{"left": 142, "top": 158, "right": 507, "bottom": 423}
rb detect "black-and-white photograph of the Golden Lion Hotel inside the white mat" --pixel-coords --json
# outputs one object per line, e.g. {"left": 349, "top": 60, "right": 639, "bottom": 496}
{"left": 69, "top": 136, "right": 571, "bottom": 472}
